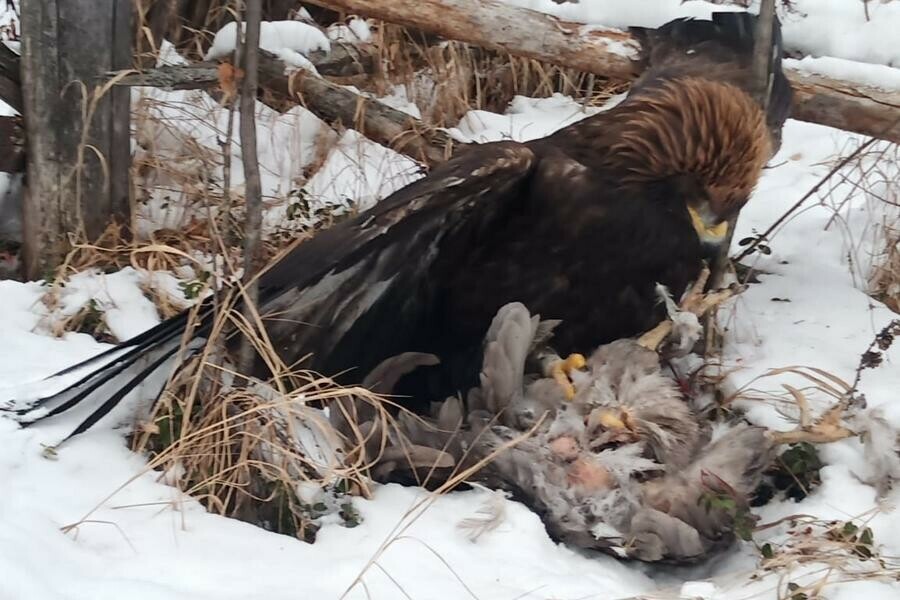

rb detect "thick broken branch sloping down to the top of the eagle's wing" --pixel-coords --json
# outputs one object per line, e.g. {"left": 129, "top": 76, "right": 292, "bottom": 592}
{"left": 259, "top": 51, "right": 454, "bottom": 165}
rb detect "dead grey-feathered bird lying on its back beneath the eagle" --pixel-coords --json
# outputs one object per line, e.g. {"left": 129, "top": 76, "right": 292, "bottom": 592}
{"left": 331, "top": 303, "right": 773, "bottom": 562}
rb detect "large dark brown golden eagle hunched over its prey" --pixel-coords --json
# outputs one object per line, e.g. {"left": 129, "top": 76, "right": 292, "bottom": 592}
{"left": 15, "top": 13, "right": 790, "bottom": 433}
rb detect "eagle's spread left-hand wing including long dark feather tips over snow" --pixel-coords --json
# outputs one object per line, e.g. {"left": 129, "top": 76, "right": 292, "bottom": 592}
{"left": 7, "top": 142, "right": 535, "bottom": 435}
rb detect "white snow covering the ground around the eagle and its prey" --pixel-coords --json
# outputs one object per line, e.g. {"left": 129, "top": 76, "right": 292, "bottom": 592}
{"left": 0, "top": 0, "right": 900, "bottom": 600}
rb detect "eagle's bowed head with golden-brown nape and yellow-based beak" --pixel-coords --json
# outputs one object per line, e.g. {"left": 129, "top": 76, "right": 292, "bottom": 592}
{"left": 610, "top": 77, "right": 772, "bottom": 243}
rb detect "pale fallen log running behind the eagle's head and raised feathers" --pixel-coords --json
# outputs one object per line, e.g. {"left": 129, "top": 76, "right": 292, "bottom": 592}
{"left": 300, "top": 0, "right": 900, "bottom": 143}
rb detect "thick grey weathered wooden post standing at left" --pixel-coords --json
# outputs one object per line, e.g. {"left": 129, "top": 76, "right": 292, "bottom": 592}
{"left": 21, "top": 0, "right": 133, "bottom": 278}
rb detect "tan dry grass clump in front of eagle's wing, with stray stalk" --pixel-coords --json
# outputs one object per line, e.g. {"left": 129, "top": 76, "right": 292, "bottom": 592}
{"left": 125, "top": 282, "right": 527, "bottom": 544}
